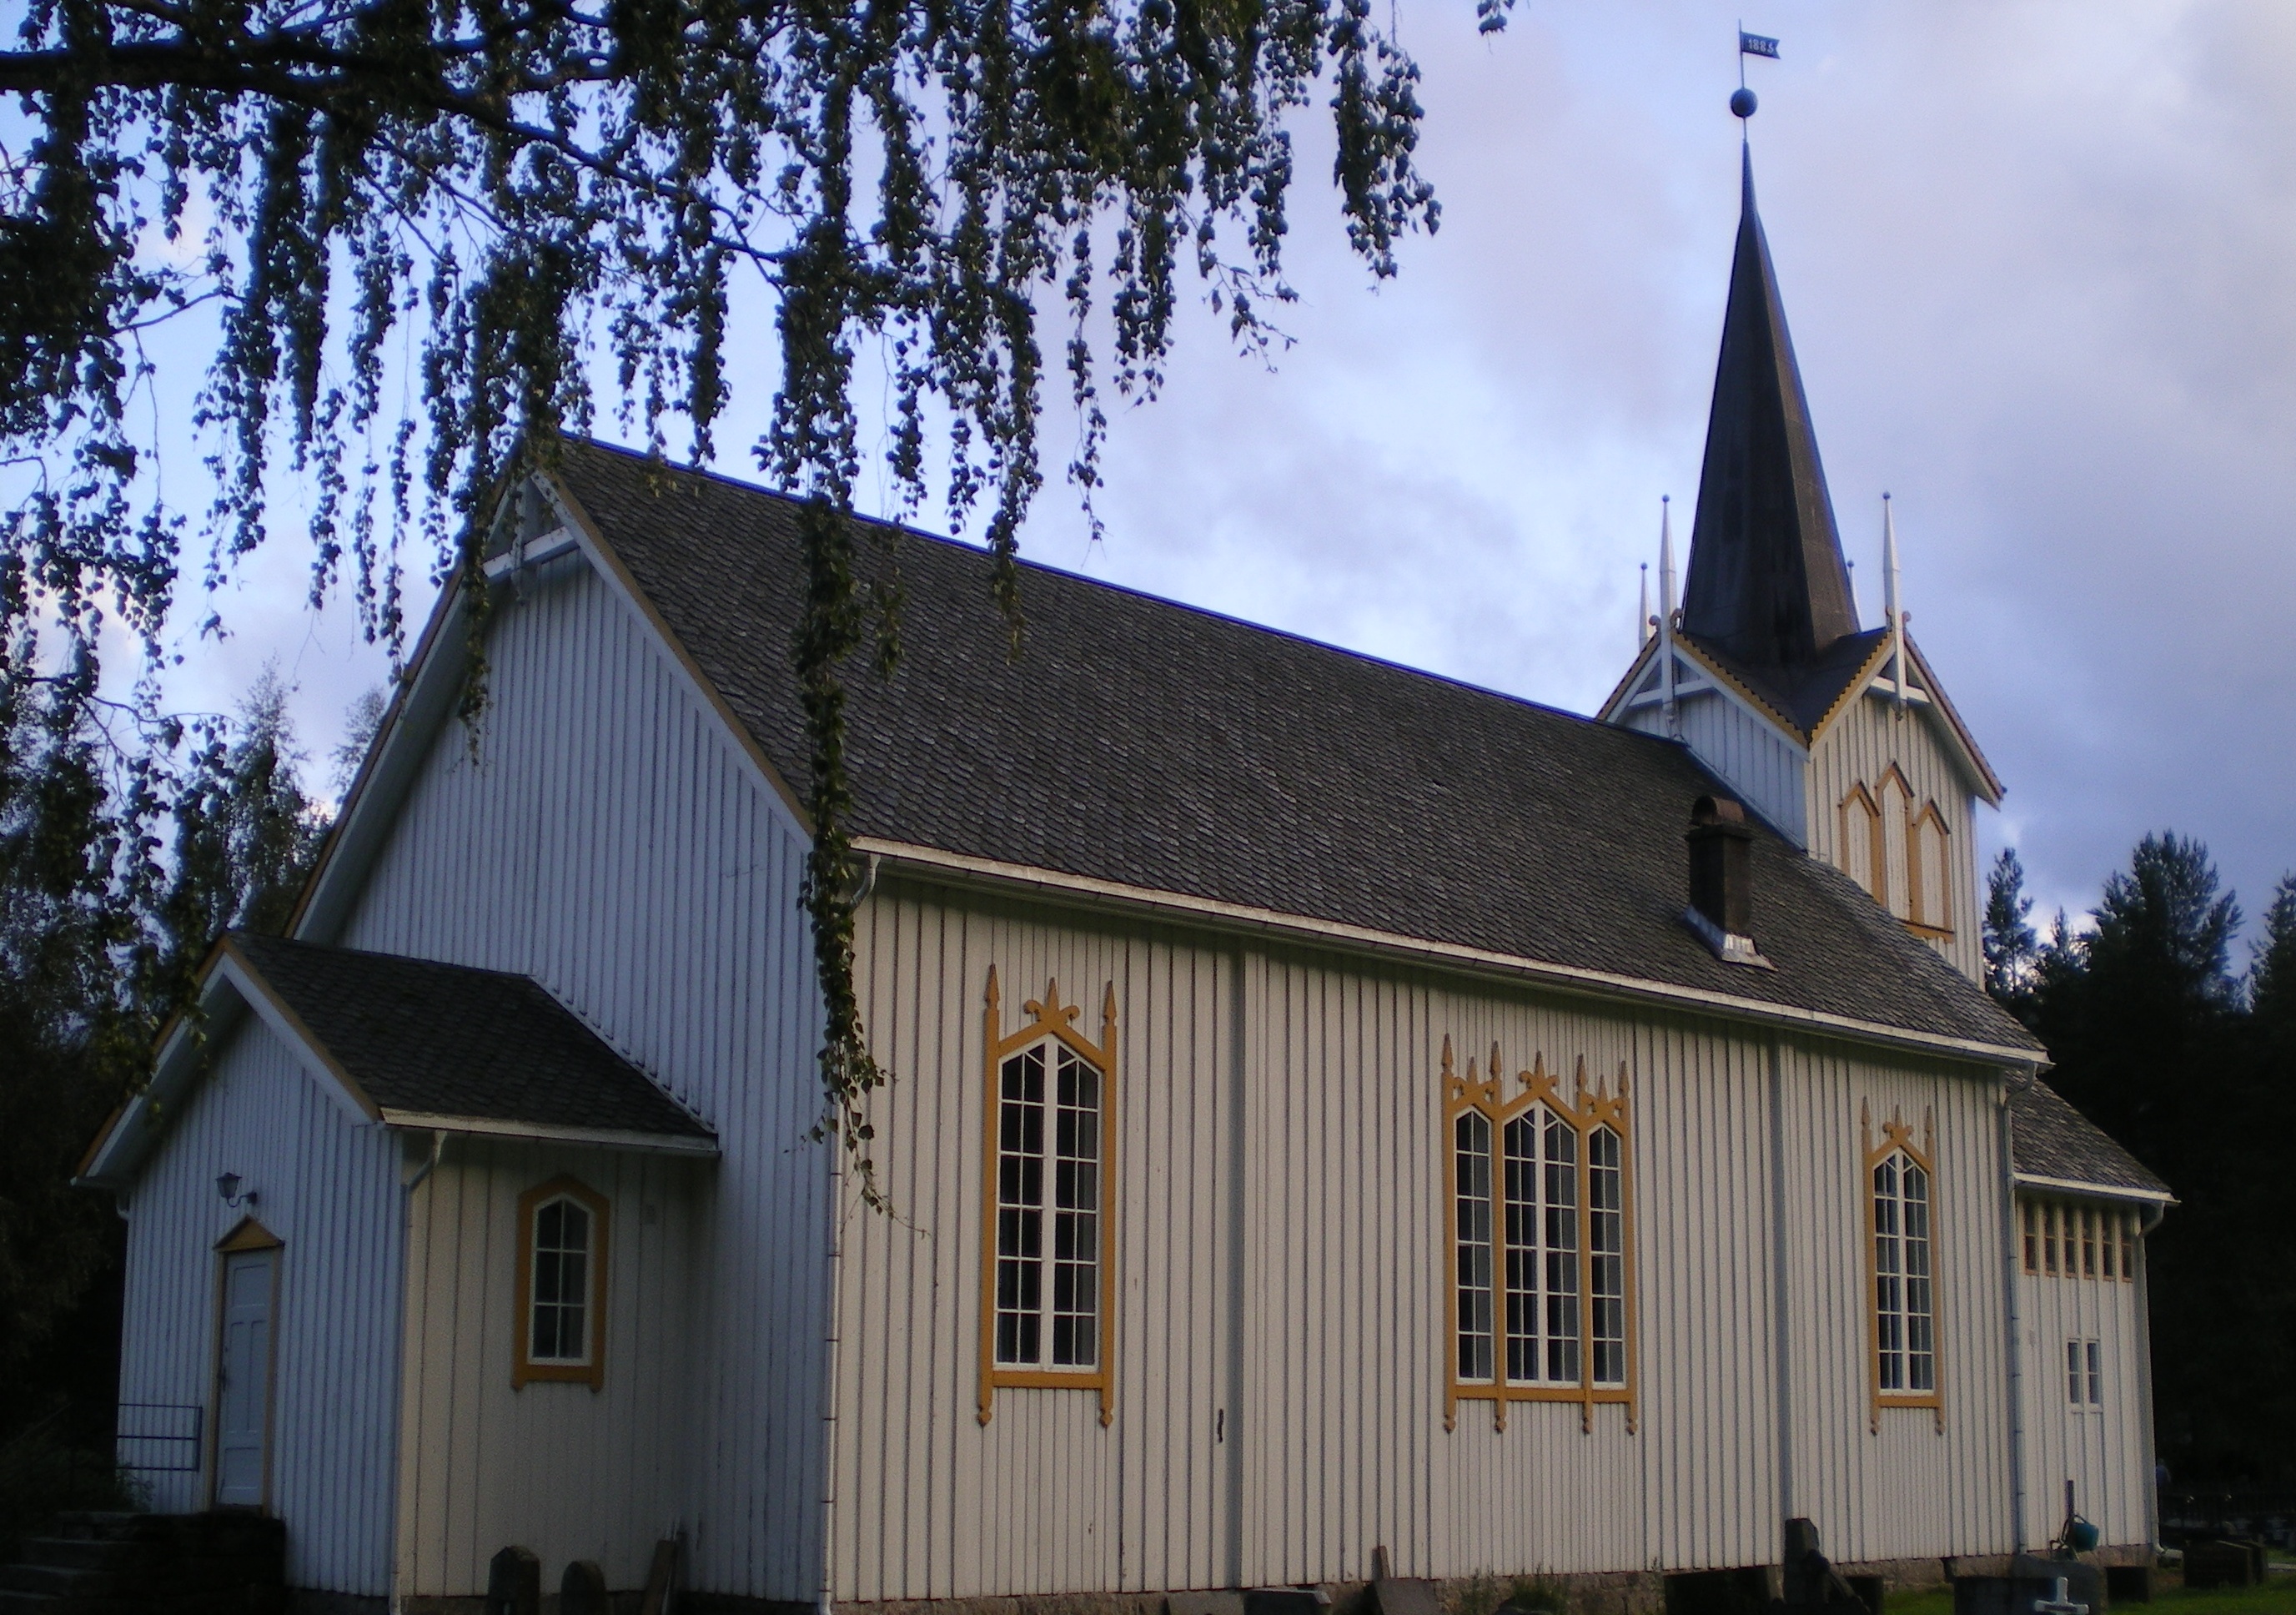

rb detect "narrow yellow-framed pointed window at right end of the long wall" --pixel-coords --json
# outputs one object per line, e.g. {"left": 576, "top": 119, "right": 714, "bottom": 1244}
{"left": 1862, "top": 1109, "right": 1945, "bottom": 1431}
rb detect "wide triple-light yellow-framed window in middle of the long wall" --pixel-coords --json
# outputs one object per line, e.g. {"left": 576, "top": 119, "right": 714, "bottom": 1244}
{"left": 1442, "top": 1039, "right": 1635, "bottom": 1429}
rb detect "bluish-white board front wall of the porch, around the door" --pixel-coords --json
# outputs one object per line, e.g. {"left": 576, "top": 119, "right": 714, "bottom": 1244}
{"left": 119, "top": 1015, "right": 404, "bottom": 1597}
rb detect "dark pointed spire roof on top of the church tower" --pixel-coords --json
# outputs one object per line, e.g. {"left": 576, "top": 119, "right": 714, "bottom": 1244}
{"left": 1683, "top": 154, "right": 1857, "bottom": 667}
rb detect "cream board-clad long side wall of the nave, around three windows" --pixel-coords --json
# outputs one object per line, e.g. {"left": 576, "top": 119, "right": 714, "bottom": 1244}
{"left": 831, "top": 880, "right": 2009, "bottom": 1601}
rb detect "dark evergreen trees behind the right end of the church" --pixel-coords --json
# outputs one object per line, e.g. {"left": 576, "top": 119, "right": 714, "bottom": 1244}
{"left": 1986, "top": 834, "right": 2296, "bottom": 1491}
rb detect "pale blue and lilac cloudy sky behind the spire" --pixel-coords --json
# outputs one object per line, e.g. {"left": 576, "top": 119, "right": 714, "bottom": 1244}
{"left": 166, "top": 0, "right": 2296, "bottom": 946}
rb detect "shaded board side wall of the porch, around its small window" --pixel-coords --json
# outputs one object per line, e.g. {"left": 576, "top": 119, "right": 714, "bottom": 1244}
{"left": 399, "top": 1140, "right": 710, "bottom": 1597}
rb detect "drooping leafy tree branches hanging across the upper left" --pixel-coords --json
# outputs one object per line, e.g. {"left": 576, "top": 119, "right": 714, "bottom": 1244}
{"left": 0, "top": 0, "right": 1509, "bottom": 1200}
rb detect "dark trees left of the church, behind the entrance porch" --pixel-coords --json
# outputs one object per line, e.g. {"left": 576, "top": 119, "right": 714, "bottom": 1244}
{"left": 0, "top": 662, "right": 324, "bottom": 1436}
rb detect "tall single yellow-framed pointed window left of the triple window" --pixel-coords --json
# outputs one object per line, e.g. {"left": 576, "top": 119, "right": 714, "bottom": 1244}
{"left": 978, "top": 967, "right": 1116, "bottom": 1424}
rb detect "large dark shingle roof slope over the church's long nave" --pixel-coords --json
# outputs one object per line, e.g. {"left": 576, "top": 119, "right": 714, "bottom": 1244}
{"left": 553, "top": 441, "right": 2041, "bottom": 1057}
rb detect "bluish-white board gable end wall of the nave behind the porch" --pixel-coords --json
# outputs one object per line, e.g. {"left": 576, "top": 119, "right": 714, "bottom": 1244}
{"left": 324, "top": 556, "right": 831, "bottom": 1601}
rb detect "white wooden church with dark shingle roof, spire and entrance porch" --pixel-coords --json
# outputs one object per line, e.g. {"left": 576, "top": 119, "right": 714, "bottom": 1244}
{"left": 83, "top": 145, "right": 2170, "bottom": 1610}
